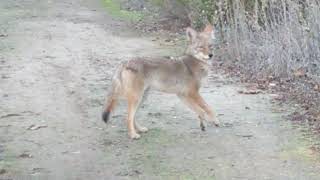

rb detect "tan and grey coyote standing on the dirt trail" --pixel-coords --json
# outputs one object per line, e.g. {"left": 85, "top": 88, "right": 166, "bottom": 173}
{"left": 102, "top": 24, "right": 219, "bottom": 139}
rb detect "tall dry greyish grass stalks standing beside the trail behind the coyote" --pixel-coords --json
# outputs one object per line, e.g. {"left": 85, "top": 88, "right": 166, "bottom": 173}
{"left": 165, "top": 0, "right": 320, "bottom": 82}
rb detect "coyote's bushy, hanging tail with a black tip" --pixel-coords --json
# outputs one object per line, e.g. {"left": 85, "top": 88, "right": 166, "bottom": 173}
{"left": 102, "top": 65, "right": 123, "bottom": 123}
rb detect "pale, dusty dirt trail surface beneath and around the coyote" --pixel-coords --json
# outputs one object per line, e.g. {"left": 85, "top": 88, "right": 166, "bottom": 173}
{"left": 0, "top": 0, "right": 320, "bottom": 180}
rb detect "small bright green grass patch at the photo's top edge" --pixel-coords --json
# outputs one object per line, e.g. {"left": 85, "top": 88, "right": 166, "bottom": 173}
{"left": 103, "top": 0, "right": 144, "bottom": 22}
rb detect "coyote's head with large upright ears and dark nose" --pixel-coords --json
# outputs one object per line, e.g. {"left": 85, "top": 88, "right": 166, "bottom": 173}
{"left": 186, "top": 24, "right": 214, "bottom": 61}
